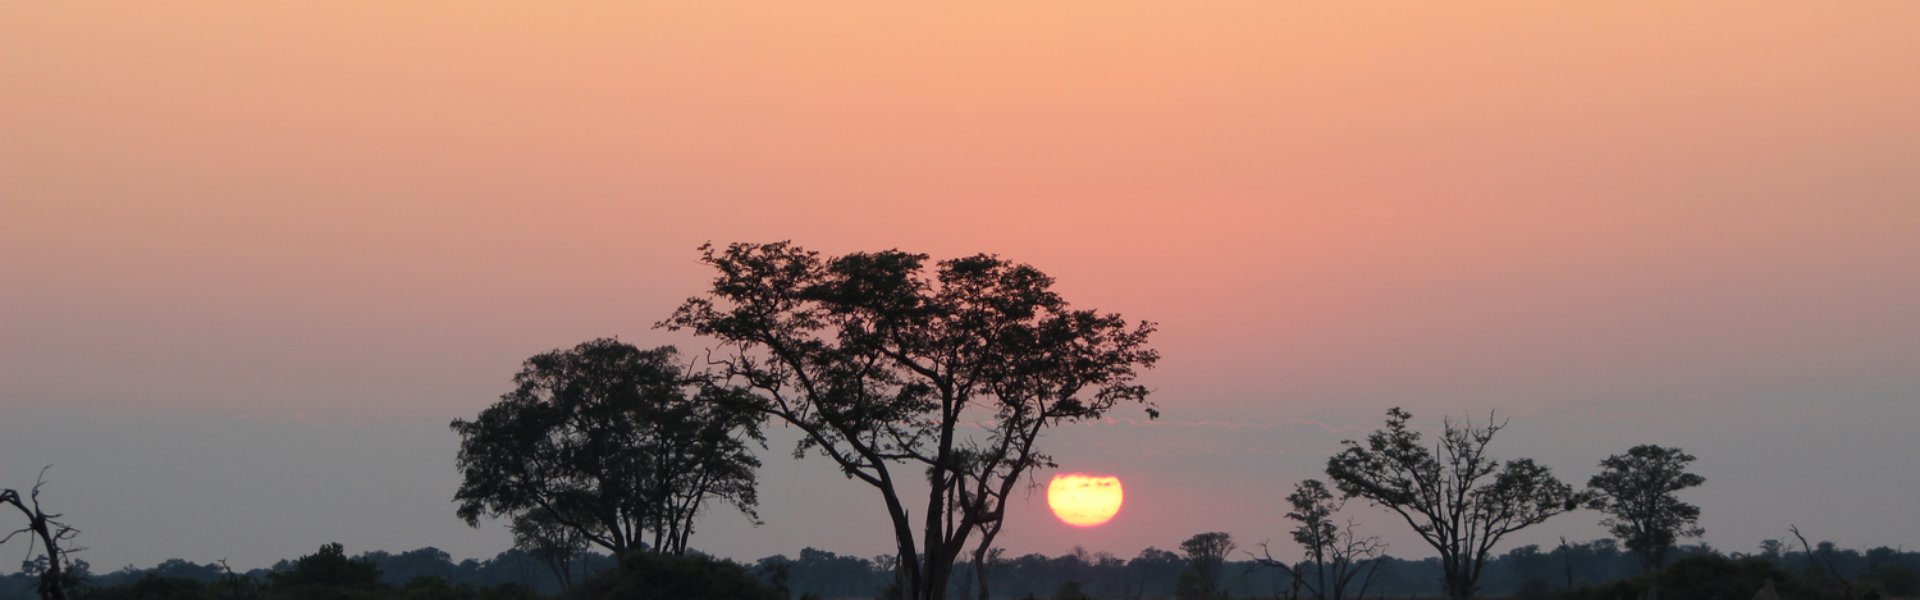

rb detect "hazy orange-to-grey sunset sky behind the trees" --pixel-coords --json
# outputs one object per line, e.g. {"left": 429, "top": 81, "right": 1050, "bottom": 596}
{"left": 0, "top": 2, "right": 1920, "bottom": 567}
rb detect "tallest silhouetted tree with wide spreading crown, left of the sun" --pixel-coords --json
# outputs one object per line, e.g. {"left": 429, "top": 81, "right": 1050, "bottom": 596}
{"left": 660, "top": 242, "right": 1158, "bottom": 598}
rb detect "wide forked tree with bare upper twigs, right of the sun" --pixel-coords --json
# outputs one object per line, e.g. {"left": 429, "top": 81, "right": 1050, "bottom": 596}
{"left": 1327, "top": 408, "right": 1584, "bottom": 600}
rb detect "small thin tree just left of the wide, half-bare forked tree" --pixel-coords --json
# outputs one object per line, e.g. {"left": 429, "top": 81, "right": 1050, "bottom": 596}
{"left": 1260, "top": 479, "right": 1386, "bottom": 600}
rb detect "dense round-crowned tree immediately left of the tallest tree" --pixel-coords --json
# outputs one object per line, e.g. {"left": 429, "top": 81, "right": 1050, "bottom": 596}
{"left": 453, "top": 338, "right": 762, "bottom": 558}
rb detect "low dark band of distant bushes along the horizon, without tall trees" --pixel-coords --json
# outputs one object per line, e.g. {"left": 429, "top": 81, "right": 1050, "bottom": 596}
{"left": 0, "top": 538, "right": 1920, "bottom": 600}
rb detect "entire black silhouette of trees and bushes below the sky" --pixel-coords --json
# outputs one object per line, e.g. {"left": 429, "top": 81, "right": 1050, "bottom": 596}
{"left": 0, "top": 242, "right": 1920, "bottom": 600}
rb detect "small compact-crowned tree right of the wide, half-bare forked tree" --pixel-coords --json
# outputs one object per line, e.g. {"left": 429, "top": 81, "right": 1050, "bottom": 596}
{"left": 1586, "top": 444, "right": 1707, "bottom": 573}
